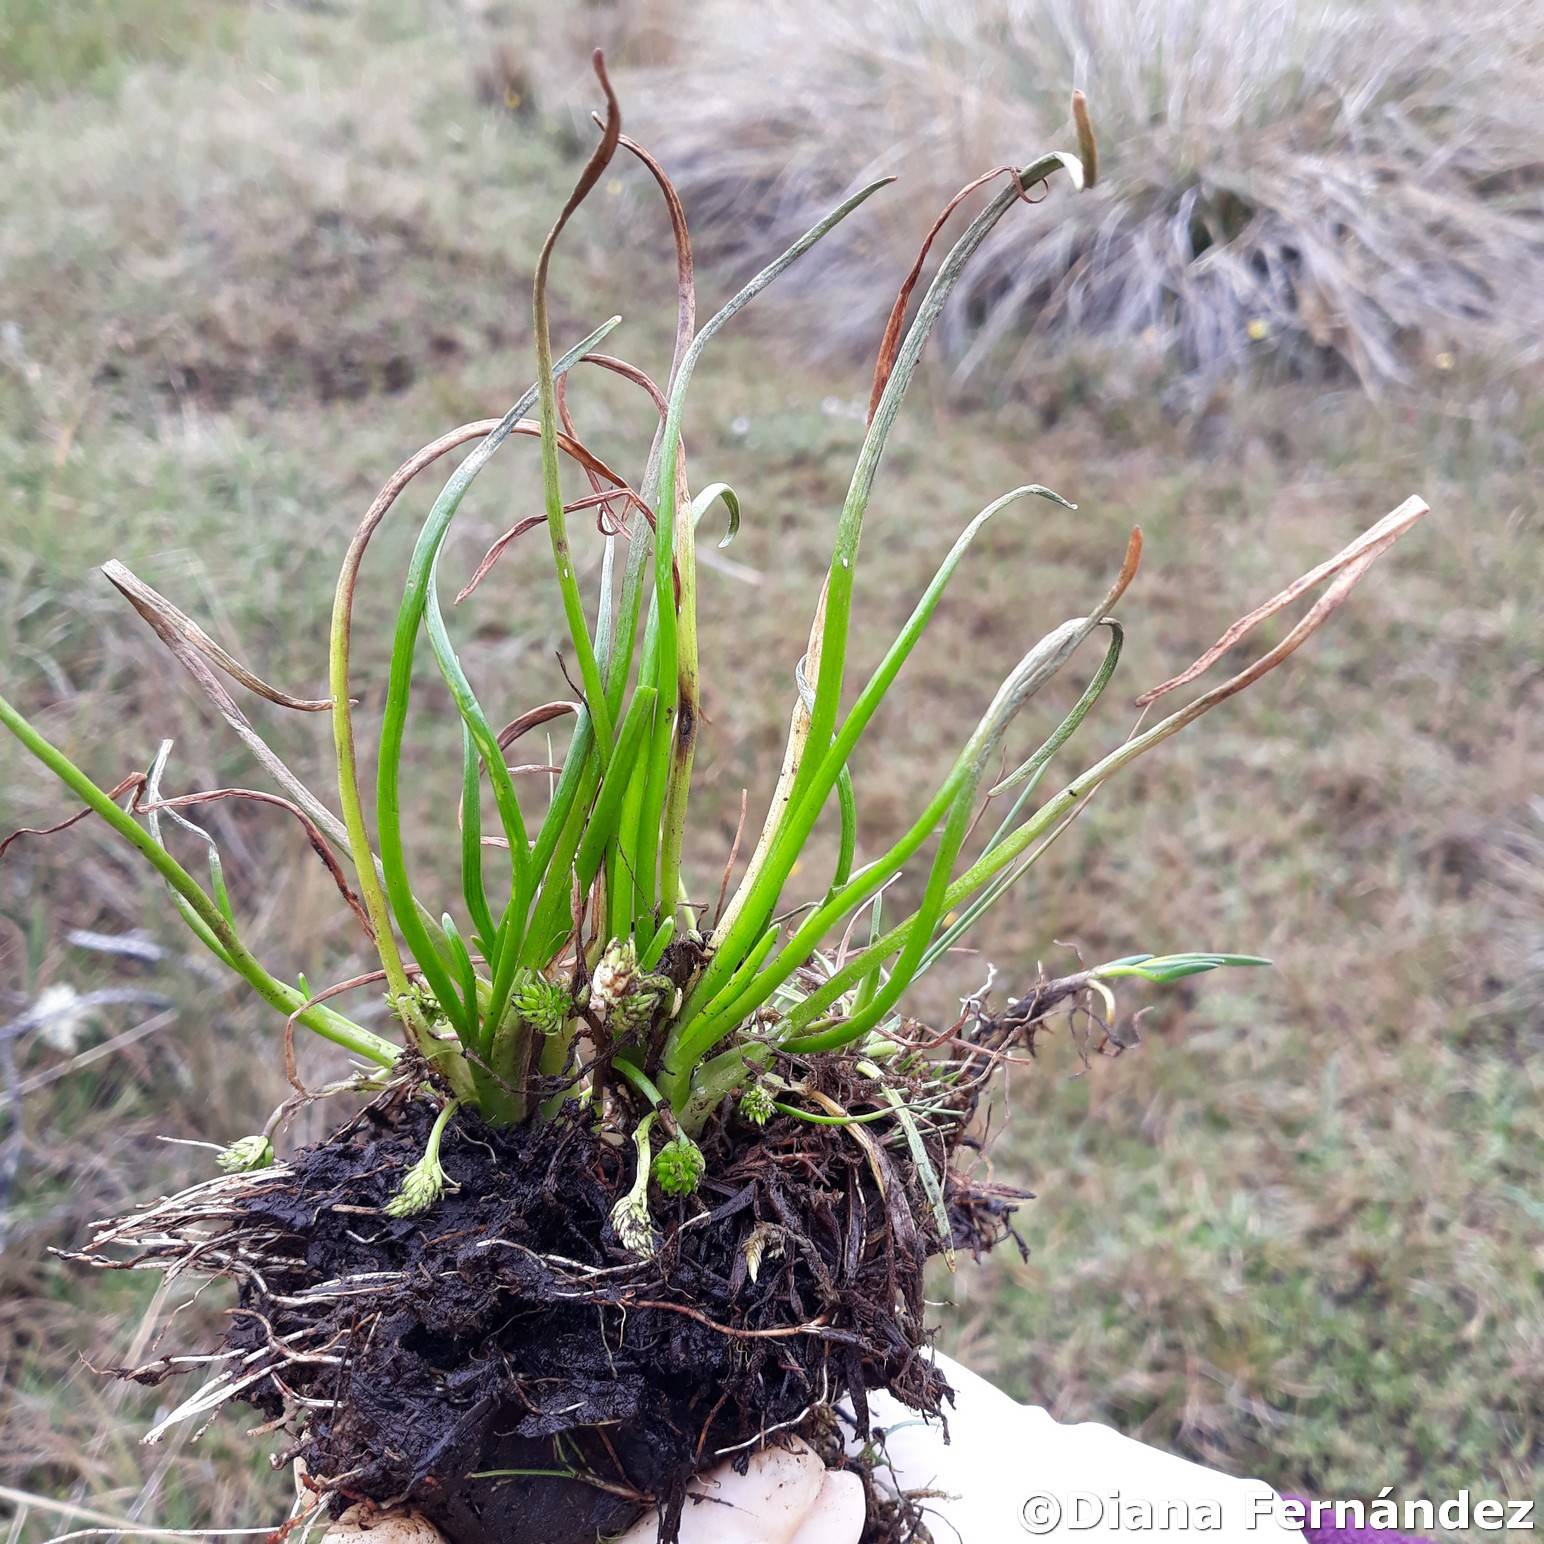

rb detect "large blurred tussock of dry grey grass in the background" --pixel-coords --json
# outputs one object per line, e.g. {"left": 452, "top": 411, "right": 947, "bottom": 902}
{"left": 586, "top": 0, "right": 1544, "bottom": 386}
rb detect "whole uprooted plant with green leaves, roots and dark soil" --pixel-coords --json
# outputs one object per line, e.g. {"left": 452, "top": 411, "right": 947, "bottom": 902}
{"left": 0, "top": 45, "right": 1425, "bottom": 1544}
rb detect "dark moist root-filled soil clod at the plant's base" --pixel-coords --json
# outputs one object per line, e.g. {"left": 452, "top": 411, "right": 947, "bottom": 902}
{"left": 88, "top": 994, "right": 1062, "bottom": 1544}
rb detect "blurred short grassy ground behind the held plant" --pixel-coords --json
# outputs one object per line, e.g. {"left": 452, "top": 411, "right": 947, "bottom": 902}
{"left": 0, "top": 0, "right": 1544, "bottom": 1539}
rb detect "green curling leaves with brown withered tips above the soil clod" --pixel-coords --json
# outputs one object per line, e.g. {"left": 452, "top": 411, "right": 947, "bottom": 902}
{"left": 0, "top": 69, "right": 1420, "bottom": 1216}
